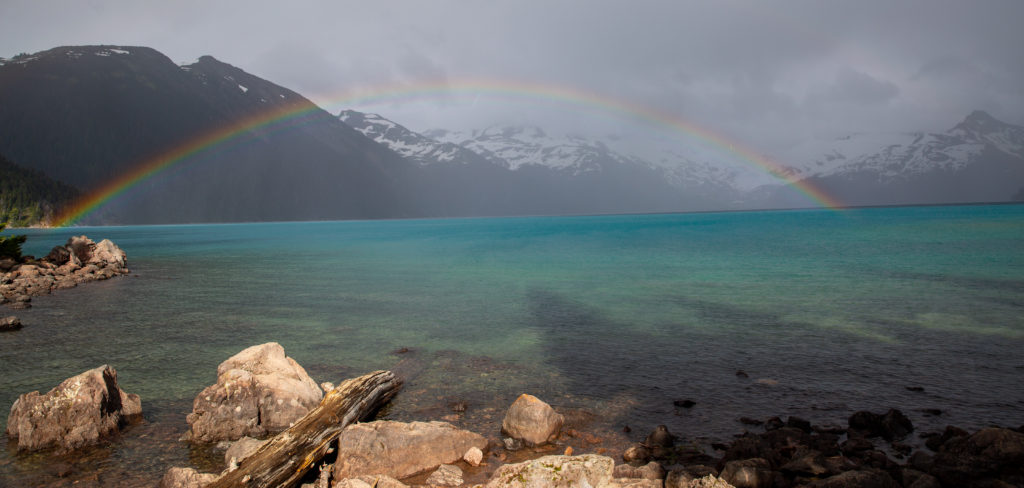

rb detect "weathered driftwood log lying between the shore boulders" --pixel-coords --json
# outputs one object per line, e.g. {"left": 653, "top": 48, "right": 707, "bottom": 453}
{"left": 207, "top": 371, "right": 401, "bottom": 488}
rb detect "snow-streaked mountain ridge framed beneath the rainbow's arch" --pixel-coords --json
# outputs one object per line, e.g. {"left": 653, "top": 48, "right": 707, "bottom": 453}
{"left": 338, "top": 110, "right": 736, "bottom": 215}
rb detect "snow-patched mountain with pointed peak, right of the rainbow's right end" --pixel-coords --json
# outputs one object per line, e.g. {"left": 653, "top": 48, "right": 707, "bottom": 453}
{"left": 759, "top": 110, "right": 1024, "bottom": 206}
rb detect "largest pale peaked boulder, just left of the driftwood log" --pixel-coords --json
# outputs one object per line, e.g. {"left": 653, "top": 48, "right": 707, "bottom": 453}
{"left": 186, "top": 343, "right": 324, "bottom": 442}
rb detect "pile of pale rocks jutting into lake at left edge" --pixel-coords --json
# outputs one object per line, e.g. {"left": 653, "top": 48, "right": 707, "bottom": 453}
{"left": 0, "top": 235, "right": 129, "bottom": 309}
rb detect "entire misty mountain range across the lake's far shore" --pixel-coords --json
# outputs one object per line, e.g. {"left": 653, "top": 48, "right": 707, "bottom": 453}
{"left": 0, "top": 46, "right": 1024, "bottom": 224}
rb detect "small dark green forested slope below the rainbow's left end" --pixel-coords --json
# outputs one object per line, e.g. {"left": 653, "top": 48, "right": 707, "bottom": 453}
{"left": 0, "top": 154, "right": 79, "bottom": 227}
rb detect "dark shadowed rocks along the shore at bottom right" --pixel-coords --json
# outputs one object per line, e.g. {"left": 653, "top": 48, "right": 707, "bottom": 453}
{"left": 610, "top": 409, "right": 1024, "bottom": 488}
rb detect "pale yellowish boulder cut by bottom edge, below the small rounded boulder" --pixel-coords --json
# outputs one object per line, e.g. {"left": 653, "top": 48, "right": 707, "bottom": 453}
{"left": 484, "top": 454, "right": 615, "bottom": 488}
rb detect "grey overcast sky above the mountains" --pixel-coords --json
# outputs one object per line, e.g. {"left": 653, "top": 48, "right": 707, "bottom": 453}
{"left": 0, "top": 0, "right": 1024, "bottom": 153}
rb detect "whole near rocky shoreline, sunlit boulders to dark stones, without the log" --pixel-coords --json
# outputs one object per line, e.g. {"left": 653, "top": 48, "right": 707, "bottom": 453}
{"left": 7, "top": 343, "right": 1024, "bottom": 488}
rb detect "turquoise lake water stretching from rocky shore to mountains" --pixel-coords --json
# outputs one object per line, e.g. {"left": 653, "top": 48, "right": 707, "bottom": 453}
{"left": 0, "top": 205, "right": 1024, "bottom": 486}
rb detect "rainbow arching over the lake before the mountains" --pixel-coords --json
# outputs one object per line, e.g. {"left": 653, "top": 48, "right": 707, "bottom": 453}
{"left": 54, "top": 80, "right": 844, "bottom": 227}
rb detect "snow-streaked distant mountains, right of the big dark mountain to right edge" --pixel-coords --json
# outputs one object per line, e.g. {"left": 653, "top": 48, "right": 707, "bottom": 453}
{"left": 340, "top": 110, "right": 1024, "bottom": 210}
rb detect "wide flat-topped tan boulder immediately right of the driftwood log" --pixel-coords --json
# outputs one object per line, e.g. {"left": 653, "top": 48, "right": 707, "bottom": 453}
{"left": 333, "top": 420, "right": 487, "bottom": 480}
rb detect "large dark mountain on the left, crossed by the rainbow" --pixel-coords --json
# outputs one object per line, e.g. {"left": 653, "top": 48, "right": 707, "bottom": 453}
{"left": 0, "top": 46, "right": 419, "bottom": 223}
